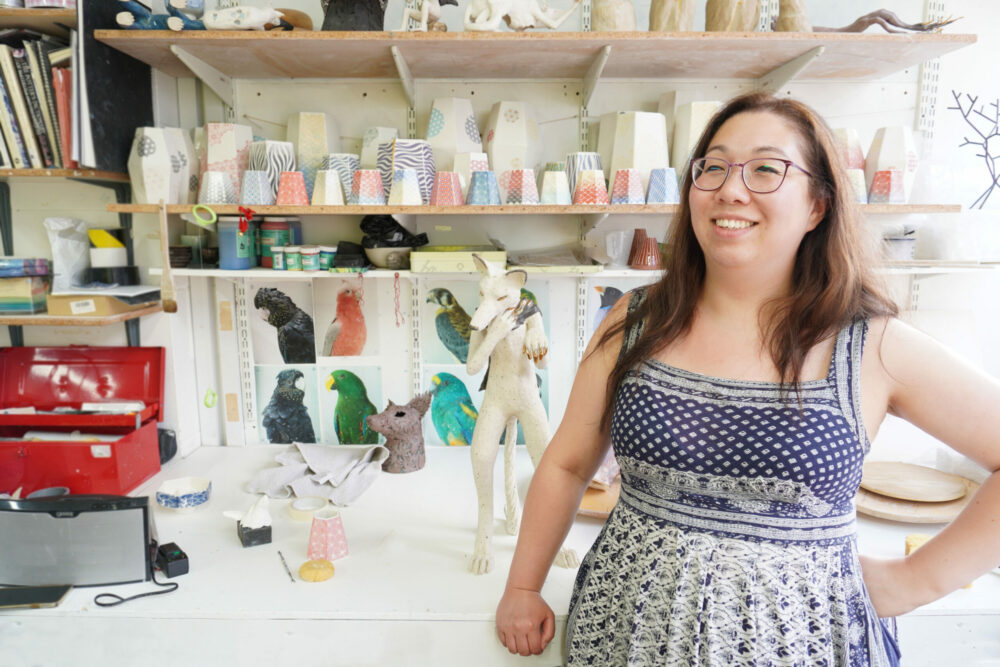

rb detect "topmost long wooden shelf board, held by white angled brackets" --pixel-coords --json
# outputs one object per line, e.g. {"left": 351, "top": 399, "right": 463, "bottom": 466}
{"left": 94, "top": 30, "right": 976, "bottom": 80}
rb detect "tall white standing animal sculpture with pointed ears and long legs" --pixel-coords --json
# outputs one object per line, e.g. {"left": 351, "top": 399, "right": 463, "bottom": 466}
{"left": 466, "top": 255, "right": 580, "bottom": 574}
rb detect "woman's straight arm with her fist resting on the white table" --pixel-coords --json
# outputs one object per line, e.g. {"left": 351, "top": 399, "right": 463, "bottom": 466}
{"left": 497, "top": 295, "right": 628, "bottom": 655}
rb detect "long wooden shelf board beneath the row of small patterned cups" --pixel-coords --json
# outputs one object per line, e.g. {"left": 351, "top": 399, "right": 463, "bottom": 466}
{"left": 103, "top": 202, "right": 962, "bottom": 217}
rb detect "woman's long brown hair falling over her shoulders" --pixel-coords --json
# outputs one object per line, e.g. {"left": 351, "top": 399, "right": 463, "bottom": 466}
{"left": 598, "top": 92, "right": 898, "bottom": 430}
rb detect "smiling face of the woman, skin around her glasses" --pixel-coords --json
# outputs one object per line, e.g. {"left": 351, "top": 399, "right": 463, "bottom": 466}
{"left": 689, "top": 111, "right": 825, "bottom": 277}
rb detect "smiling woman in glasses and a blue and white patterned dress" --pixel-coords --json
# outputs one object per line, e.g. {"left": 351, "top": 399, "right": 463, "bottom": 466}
{"left": 497, "top": 93, "right": 1000, "bottom": 666}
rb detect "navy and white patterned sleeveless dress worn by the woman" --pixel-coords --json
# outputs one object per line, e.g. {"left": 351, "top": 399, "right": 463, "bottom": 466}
{"left": 566, "top": 292, "right": 899, "bottom": 667}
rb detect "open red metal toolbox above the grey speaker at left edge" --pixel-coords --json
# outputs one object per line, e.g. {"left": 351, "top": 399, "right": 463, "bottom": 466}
{"left": 0, "top": 347, "right": 164, "bottom": 497}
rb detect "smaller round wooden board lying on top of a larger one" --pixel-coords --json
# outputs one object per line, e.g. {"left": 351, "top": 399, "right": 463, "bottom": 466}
{"left": 861, "top": 461, "right": 968, "bottom": 503}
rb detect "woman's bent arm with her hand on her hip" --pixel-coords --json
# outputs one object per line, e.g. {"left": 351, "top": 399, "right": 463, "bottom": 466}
{"left": 862, "top": 320, "right": 1000, "bottom": 616}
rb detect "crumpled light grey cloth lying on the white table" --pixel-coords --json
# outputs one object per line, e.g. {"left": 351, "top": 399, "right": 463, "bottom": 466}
{"left": 248, "top": 442, "right": 389, "bottom": 505}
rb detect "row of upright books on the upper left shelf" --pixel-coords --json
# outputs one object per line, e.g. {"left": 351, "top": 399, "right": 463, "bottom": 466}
{"left": 0, "top": 28, "right": 76, "bottom": 169}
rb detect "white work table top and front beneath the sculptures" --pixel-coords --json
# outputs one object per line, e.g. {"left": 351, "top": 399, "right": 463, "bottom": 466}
{"left": 0, "top": 446, "right": 1000, "bottom": 667}
